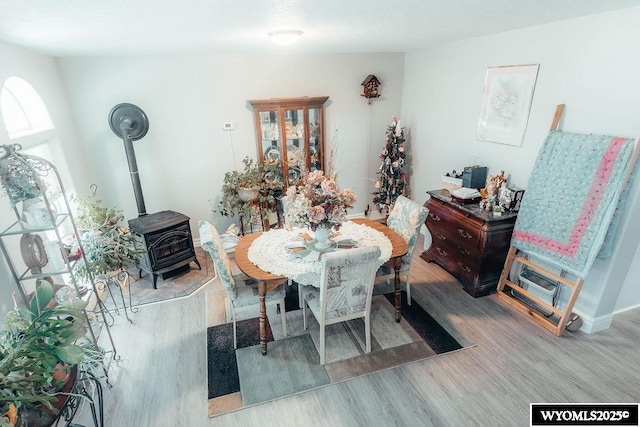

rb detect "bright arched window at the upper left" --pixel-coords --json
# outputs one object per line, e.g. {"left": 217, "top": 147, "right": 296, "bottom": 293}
{"left": 0, "top": 76, "right": 53, "bottom": 142}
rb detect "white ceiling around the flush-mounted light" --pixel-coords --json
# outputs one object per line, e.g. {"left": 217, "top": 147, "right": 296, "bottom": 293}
{"left": 0, "top": 0, "right": 640, "bottom": 56}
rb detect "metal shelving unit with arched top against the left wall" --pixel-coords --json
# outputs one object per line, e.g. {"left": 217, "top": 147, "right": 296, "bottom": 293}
{"left": 0, "top": 144, "right": 119, "bottom": 380}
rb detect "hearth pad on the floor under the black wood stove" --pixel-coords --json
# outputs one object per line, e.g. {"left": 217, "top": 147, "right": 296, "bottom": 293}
{"left": 102, "top": 247, "right": 215, "bottom": 312}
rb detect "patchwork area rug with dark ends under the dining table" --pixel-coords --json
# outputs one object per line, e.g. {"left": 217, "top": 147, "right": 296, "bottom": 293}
{"left": 207, "top": 292, "right": 472, "bottom": 416}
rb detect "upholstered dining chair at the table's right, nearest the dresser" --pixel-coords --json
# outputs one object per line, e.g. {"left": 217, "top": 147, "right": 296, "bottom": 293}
{"left": 376, "top": 196, "right": 429, "bottom": 305}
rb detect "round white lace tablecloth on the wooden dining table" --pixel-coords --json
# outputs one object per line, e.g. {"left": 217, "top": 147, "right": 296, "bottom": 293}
{"left": 247, "top": 221, "right": 393, "bottom": 287}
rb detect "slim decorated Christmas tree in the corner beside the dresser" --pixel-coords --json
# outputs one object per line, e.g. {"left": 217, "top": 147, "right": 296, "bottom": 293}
{"left": 372, "top": 117, "right": 406, "bottom": 213}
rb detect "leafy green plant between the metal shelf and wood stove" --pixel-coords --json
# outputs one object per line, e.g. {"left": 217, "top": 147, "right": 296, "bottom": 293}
{"left": 74, "top": 197, "right": 145, "bottom": 282}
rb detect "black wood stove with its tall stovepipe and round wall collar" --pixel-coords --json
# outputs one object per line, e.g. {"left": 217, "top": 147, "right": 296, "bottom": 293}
{"left": 109, "top": 104, "right": 202, "bottom": 289}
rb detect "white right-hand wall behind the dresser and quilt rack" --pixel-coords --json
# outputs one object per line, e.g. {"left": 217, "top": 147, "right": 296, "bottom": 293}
{"left": 402, "top": 8, "right": 640, "bottom": 331}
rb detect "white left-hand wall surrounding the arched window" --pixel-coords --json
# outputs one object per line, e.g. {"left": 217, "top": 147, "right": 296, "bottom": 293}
{"left": 0, "top": 41, "right": 85, "bottom": 323}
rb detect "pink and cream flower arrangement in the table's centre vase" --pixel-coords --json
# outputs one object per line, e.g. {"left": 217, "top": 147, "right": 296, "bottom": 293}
{"left": 283, "top": 171, "right": 357, "bottom": 231}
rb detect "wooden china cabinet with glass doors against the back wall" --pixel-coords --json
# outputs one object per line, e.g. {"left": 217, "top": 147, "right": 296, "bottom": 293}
{"left": 249, "top": 96, "right": 329, "bottom": 189}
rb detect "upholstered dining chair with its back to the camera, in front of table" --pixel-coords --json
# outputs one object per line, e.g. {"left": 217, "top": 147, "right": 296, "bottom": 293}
{"left": 302, "top": 246, "right": 380, "bottom": 365}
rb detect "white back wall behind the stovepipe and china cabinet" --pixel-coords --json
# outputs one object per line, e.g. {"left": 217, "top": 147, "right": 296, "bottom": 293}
{"left": 58, "top": 54, "right": 404, "bottom": 236}
